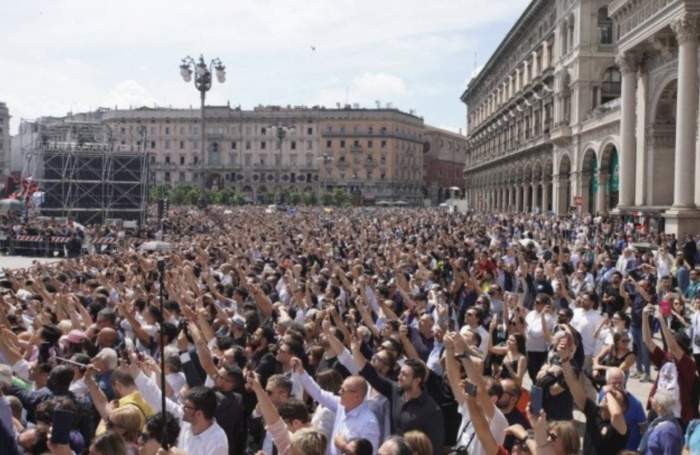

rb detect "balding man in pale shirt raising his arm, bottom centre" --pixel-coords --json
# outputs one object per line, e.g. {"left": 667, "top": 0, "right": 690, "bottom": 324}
{"left": 292, "top": 357, "right": 379, "bottom": 455}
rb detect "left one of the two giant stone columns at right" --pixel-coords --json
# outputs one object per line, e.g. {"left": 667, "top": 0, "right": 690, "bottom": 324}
{"left": 615, "top": 52, "right": 636, "bottom": 207}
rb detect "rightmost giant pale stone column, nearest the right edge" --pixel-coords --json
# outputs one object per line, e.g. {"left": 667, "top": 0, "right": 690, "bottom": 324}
{"left": 671, "top": 14, "right": 698, "bottom": 208}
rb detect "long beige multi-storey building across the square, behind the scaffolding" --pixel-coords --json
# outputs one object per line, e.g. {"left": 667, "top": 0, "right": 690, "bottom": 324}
{"left": 18, "top": 106, "right": 425, "bottom": 204}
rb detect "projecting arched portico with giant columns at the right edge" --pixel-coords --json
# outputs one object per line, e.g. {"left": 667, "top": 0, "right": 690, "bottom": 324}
{"left": 610, "top": 0, "right": 700, "bottom": 234}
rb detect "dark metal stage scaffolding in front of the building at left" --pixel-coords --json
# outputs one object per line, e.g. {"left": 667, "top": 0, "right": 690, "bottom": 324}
{"left": 23, "top": 140, "right": 149, "bottom": 226}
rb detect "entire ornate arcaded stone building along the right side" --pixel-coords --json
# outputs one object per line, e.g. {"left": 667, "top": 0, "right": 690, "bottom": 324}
{"left": 462, "top": 0, "right": 700, "bottom": 235}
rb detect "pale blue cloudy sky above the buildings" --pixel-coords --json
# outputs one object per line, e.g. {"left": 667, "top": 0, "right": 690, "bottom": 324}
{"left": 0, "top": 0, "right": 528, "bottom": 132}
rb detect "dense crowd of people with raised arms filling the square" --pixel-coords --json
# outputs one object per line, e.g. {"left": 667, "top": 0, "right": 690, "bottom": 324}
{"left": 0, "top": 207, "right": 700, "bottom": 455}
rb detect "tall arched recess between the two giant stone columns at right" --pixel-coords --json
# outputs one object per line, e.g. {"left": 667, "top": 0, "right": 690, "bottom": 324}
{"left": 645, "top": 79, "right": 678, "bottom": 206}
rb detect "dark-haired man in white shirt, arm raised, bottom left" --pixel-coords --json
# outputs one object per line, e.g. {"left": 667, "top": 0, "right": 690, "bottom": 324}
{"left": 132, "top": 371, "right": 228, "bottom": 455}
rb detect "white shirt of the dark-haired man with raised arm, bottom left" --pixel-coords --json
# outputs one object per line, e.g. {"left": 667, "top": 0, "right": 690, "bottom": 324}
{"left": 134, "top": 373, "right": 228, "bottom": 455}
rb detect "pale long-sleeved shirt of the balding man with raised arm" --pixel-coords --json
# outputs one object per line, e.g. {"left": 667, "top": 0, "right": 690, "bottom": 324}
{"left": 294, "top": 372, "right": 379, "bottom": 455}
